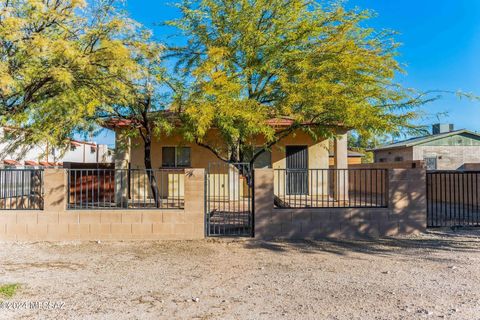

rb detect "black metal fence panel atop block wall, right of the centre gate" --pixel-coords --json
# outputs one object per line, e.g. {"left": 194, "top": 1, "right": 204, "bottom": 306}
{"left": 274, "top": 169, "right": 388, "bottom": 208}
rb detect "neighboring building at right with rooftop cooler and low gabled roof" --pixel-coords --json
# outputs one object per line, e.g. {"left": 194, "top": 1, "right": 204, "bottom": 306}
{"left": 372, "top": 124, "right": 480, "bottom": 170}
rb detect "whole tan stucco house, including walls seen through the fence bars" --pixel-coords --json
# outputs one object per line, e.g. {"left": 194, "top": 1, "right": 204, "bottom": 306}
{"left": 108, "top": 119, "right": 348, "bottom": 198}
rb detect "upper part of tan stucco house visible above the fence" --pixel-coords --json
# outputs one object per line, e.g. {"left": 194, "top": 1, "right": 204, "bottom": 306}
{"left": 109, "top": 119, "right": 348, "bottom": 169}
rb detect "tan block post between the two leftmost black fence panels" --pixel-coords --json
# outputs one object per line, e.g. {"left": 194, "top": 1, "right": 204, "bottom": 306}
{"left": 43, "top": 169, "right": 67, "bottom": 212}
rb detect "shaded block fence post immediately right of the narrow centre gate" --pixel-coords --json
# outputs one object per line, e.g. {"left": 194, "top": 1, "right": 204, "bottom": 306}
{"left": 253, "top": 169, "right": 275, "bottom": 238}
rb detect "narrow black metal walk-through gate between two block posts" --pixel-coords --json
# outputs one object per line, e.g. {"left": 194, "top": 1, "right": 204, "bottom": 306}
{"left": 205, "top": 163, "right": 254, "bottom": 237}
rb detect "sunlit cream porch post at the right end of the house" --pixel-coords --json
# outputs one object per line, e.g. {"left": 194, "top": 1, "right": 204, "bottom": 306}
{"left": 333, "top": 132, "right": 348, "bottom": 201}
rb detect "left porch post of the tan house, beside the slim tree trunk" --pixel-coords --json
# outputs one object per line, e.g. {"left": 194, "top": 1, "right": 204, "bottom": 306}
{"left": 114, "top": 131, "right": 131, "bottom": 207}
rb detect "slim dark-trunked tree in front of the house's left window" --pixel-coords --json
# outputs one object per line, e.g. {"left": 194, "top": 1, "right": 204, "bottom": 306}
{"left": 94, "top": 39, "right": 175, "bottom": 206}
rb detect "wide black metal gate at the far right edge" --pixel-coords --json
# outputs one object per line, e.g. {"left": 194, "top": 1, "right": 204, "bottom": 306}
{"left": 427, "top": 171, "right": 480, "bottom": 228}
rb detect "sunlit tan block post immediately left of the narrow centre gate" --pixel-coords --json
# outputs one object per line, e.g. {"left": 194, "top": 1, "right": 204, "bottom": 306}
{"left": 184, "top": 168, "right": 205, "bottom": 239}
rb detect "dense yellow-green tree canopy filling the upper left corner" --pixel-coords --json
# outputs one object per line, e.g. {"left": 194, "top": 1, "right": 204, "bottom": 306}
{"left": 0, "top": 0, "right": 138, "bottom": 155}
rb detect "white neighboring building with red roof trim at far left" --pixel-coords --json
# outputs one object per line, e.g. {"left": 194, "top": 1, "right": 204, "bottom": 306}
{"left": 0, "top": 129, "right": 113, "bottom": 167}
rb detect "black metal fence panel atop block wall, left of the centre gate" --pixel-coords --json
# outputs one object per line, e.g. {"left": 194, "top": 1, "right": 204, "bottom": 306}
{"left": 67, "top": 169, "right": 185, "bottom": 210}
